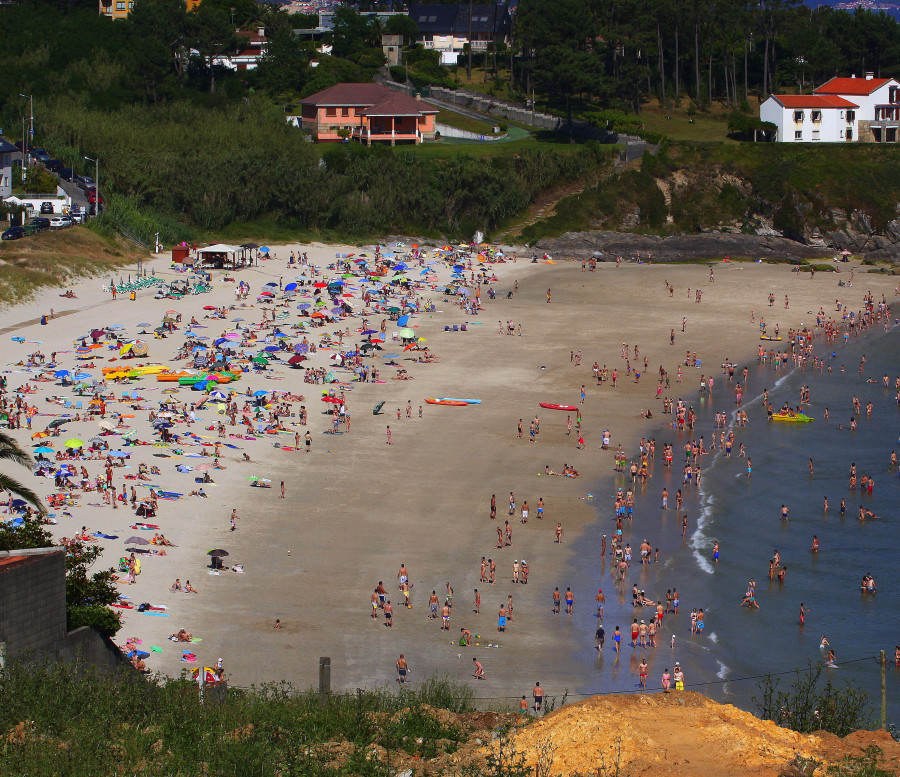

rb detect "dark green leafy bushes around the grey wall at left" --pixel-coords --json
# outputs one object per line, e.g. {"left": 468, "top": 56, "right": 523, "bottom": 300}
{"left": 0, "top": 519, "right": 121, "bottom": 637}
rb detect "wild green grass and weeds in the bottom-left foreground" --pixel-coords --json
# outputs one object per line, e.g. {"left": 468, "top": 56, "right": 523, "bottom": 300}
{"left": 0, "top": 660, "right": 474, "bottom": 777}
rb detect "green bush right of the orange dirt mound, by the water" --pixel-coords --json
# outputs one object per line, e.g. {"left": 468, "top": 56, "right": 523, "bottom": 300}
{"left": 753, "top": 662, "right": 871, "bottom": 737}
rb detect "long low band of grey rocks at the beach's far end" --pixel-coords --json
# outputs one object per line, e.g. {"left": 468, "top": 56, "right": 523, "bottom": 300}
{"left": 534, "top": 232, "right": 834, "bottom": 264}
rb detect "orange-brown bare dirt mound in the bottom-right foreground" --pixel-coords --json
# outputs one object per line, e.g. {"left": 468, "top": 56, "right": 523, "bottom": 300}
{"left": 450, "top": 693, "right": 900, "bottom": 777}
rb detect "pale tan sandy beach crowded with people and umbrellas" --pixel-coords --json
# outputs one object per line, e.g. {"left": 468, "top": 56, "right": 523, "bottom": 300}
{"left": 0, "top": 245, "right": 895, "bottom": 698}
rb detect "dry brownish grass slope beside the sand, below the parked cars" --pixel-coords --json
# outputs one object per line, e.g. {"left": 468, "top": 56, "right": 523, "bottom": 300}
{"left": 0, "top": 226, "right": 141, "bottom": 305}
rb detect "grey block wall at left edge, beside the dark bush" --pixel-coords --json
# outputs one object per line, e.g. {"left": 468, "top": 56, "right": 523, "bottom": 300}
{"left": 0, "top": 548, "right": 66, "bottom": 657}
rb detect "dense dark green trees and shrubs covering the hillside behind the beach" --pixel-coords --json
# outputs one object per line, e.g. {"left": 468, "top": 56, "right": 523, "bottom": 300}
{"left": 0, "top": 0, "right": 900, "bottom": 241}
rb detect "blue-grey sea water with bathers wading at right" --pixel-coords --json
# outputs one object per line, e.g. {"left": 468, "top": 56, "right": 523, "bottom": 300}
{"left": 576, "top": 318, "right": 900, "bottom": 722}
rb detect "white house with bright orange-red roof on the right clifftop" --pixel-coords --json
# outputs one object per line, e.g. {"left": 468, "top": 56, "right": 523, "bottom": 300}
{"left": 759, "top": 73, "right": 900, "bottom": 143}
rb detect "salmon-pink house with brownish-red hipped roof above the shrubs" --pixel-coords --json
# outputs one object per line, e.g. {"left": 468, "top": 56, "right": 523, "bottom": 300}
{"left": 300, "top": 83, "right": 438, "bottom": 146}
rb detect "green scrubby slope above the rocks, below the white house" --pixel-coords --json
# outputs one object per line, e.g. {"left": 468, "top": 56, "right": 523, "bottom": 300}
{"left": 523, "top": 142, "right": 900, "bottom": 242}
